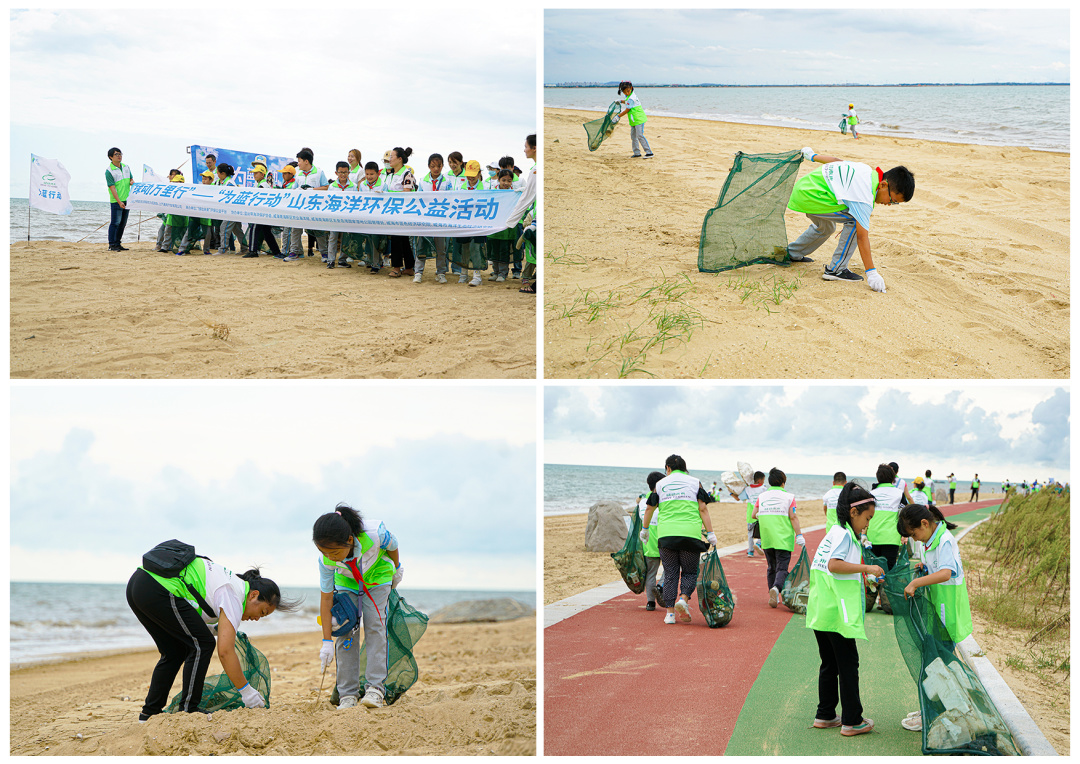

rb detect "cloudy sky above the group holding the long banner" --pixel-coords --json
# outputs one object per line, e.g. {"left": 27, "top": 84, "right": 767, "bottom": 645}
{"left": 10, "top": 3, "right": 540, "bottom": 201}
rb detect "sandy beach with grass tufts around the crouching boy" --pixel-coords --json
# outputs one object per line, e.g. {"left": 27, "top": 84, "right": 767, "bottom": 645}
{"left": 543, "top": 108, "right": 1070, "bottom": 379}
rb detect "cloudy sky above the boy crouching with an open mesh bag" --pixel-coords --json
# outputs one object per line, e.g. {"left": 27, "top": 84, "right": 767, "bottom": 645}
{"left": 543, "top": 9, "right": 1069, "bottom": 84}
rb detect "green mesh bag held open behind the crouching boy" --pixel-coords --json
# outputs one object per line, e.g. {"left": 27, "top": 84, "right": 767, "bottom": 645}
{"left": 698, "top": 151, "right": 802, "bottom": 273}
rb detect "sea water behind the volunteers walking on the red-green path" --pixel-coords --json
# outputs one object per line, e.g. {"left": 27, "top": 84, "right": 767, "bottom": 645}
{"left": 543, "top": 465, "right": 1001, "bottom": 515}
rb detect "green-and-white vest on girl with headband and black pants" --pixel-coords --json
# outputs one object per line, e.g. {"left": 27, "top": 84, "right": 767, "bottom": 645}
{"left": 807, "top": 525, "right": 866, "bottom": 640}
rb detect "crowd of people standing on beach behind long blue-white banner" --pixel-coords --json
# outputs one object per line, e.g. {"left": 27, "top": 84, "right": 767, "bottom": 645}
{"left": 106, "top": 134, "right": 538, "bottom": 294}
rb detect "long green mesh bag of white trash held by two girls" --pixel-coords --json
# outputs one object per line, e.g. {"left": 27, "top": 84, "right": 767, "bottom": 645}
{"left": 881, "top": 546, "right": 1021, "bottom": 756}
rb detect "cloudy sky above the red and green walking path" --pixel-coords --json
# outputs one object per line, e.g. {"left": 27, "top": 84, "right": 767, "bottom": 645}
{"left": 543, "top": 384, "right": 1069, "bottom": 482}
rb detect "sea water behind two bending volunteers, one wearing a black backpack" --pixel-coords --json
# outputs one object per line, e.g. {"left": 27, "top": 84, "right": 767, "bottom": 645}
{"left": 10, "top": 581, "right": 537, "bottom": 665}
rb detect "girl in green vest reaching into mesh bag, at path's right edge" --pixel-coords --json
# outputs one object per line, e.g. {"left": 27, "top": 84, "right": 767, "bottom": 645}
{"left": 896, "top": 505, "right": 972, "bottom": 731}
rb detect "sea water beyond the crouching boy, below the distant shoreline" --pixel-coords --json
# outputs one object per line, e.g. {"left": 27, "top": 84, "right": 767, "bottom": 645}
{"left": 544, "top": 85, "right": 1069, "bottom": 152}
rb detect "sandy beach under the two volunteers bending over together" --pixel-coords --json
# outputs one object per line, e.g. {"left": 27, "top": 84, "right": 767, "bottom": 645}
{"left": 11, "top": 616, "right": 537, "bottom": 755}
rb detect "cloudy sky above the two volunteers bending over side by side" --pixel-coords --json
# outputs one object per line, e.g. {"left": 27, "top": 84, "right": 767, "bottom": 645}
{"left": 11, "top": 389, "right": 537, "bottom": 590}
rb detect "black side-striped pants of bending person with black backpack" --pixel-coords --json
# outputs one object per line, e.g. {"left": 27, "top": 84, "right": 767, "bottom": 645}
{"left": 127, "top": 568, "right": 216, "bottom": 716}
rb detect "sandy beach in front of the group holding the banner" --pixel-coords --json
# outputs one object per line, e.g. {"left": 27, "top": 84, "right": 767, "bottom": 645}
{"left": 10, "top": 240, "right": 536, "bottom": 379}
